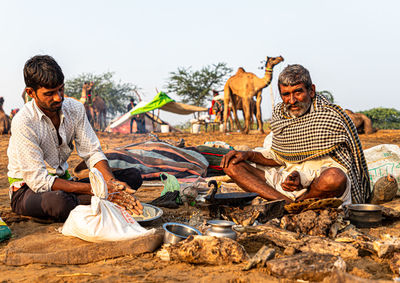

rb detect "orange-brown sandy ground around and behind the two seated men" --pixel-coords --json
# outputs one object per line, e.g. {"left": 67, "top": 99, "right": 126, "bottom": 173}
{"left": 0, "top": 130, "right": 400, "bottom": 282}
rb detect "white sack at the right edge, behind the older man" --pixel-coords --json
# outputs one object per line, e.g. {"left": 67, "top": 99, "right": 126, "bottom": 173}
{"left": 364, "top": 144, "right": 400, "bottom": 193}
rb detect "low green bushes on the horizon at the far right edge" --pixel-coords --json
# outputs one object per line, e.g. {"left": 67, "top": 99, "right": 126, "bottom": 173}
{"left": 360, "top": 107, "right": 400, "bottom": 129}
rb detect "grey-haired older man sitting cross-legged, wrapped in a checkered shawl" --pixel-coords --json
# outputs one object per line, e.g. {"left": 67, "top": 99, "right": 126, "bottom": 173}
{"left": 221, "top": 65, "right": 370, "bottom": 204}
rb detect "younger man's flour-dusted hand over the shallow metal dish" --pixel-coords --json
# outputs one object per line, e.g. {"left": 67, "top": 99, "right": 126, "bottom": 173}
{"left": 107, "top": 178, "right": 143, "bottom": 215}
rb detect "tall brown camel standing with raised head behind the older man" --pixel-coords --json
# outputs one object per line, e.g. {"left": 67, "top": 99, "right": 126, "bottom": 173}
{"left": 224, "top": 56, "right": 283, "bottom": 134}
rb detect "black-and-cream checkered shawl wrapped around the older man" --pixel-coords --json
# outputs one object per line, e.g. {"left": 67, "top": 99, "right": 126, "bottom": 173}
{"left": 271, "top": 94, "right": 371, "bottom": 203}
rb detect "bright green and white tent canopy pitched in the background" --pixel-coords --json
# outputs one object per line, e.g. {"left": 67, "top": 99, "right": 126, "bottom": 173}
{"left": 107, "top": 92, "right": 208, "bottom": 133}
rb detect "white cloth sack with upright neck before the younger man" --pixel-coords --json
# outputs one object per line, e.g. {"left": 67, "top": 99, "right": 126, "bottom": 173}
{"left": 61, "top": 168, "right": 155, "bottom": 242}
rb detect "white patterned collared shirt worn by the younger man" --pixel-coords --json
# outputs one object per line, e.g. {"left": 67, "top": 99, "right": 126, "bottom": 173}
{"left": 7, "top": 98, "right": 107, "bottom": 192}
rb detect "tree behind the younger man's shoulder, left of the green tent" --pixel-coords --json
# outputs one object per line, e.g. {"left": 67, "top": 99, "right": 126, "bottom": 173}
{"left": 65, "top": 72, "right": 138, "bottom": 116}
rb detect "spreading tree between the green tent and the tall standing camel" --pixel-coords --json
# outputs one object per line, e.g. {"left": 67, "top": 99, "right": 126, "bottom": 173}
{"left": 166, "top": 63, "right": 232, "bottom": 106}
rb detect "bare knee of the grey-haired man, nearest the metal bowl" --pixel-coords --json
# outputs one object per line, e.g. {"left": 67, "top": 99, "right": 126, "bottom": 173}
{"left": 315, "top": 168, "right": 347, "bottom": 197}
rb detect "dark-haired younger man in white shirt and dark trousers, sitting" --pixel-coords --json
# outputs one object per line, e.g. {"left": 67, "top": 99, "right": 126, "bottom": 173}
{"left": 7, "top": 55, "right": 143, "bottom": 222}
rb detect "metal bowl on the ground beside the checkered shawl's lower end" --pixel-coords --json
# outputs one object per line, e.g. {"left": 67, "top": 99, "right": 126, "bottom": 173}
{"left": 347, "top": 203, "right": 382, "bottom": 228}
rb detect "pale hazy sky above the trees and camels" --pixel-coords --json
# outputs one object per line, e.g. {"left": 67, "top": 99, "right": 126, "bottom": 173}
{"left": 0, "top": 0, "right": 400, "bottom": 124}
